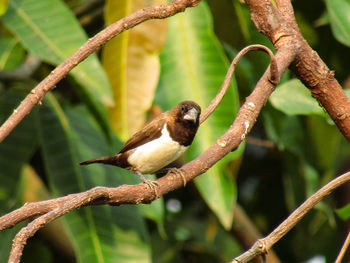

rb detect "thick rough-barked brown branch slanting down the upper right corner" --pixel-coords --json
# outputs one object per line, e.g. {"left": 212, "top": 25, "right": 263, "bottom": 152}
{"left": 246, "top": 0, "right": 350, "bottom": 142}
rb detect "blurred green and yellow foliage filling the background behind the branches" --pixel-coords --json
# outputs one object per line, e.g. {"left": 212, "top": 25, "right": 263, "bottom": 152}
{"left": 0, "top": 0, "right": 350, "bottom": 263}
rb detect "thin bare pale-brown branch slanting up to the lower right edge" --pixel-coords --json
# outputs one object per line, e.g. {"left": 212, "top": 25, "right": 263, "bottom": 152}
{"left": 232, "top": 172, "right": 350, "bottom": 263}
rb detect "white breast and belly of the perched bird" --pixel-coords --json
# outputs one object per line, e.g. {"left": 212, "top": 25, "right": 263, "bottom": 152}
{"left": 128, "top": 124, "right": 188, "bottom": 174}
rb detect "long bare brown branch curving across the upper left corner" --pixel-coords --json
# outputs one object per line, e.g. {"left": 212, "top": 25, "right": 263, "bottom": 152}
{"left": 0, "top": 0, "right": 200, "bottom": 142}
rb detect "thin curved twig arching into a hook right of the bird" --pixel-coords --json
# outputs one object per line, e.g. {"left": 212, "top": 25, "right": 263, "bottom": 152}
{"left": 199, "top": 45, "right": 280, "bottom": 124}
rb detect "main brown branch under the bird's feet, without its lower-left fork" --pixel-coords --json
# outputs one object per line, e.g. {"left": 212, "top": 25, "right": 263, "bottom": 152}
{"left": 0, "top": 45, "right": 293, "bottom": 230}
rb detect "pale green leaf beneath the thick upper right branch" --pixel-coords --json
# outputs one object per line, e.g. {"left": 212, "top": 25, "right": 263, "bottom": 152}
{"left": 270, "top": 79, "right": 326, "bottom": 116}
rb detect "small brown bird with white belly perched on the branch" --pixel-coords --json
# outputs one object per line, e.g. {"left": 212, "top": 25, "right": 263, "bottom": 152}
{"left": 80, "top": 100, "right": 201, "bottom": 196}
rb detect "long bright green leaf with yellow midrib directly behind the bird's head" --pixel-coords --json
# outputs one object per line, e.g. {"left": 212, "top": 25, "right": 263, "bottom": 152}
{"left": 156, "top": 2, "right": 241, "bottom": 228}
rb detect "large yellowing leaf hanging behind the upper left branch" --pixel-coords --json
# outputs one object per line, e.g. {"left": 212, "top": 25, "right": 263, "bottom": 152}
{"left": 102, "top": 0, "right": 166, "bottom": 140}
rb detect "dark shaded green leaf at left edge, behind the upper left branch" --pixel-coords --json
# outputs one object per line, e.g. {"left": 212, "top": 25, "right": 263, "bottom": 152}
{"left": 0, "top": 89, "right": 37, "bottom": 213}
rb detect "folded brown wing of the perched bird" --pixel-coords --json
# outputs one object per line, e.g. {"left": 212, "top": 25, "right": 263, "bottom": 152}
{"left": 119, "top": 112, "right": 168, "bottom": 153}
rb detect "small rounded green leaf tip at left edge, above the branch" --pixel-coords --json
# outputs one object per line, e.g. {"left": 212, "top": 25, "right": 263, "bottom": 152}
{"left": 0, "top": 38, "right": 24, "bottom": 71}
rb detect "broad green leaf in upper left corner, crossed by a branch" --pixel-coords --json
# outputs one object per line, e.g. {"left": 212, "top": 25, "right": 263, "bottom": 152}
{"left": 3, "top": 0, "right": 113, "bottom": 105}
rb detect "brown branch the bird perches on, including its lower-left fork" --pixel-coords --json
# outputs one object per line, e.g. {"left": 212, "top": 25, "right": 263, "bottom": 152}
{"left": 0, "top": 44, "right": 288, "bottom": 263}
